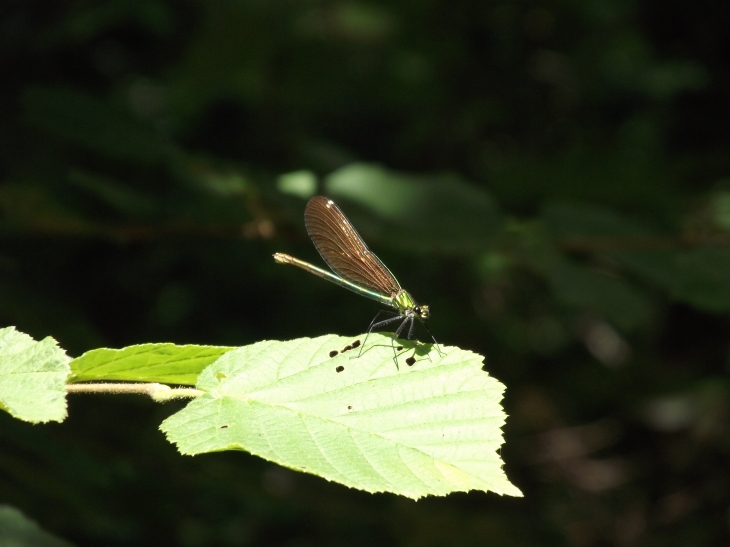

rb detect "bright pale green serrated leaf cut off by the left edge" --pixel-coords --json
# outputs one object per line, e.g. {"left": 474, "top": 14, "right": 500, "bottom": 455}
{"left": 0, "top": 327, "right": 70, "bottom": 423}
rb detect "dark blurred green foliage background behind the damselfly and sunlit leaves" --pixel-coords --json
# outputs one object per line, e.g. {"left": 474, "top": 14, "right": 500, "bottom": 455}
{"left": 0, "top": 0, "right": 730, "bottom": 547}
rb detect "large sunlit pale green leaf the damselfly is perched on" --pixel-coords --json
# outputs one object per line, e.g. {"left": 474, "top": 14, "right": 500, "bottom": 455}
{"left": 161, "top": 334, "right": 521, "bottom": 499}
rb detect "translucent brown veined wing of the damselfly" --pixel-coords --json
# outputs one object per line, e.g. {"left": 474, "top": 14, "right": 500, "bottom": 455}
{"left": 304, "top": 196, "right": 401, "bottom": 296}
